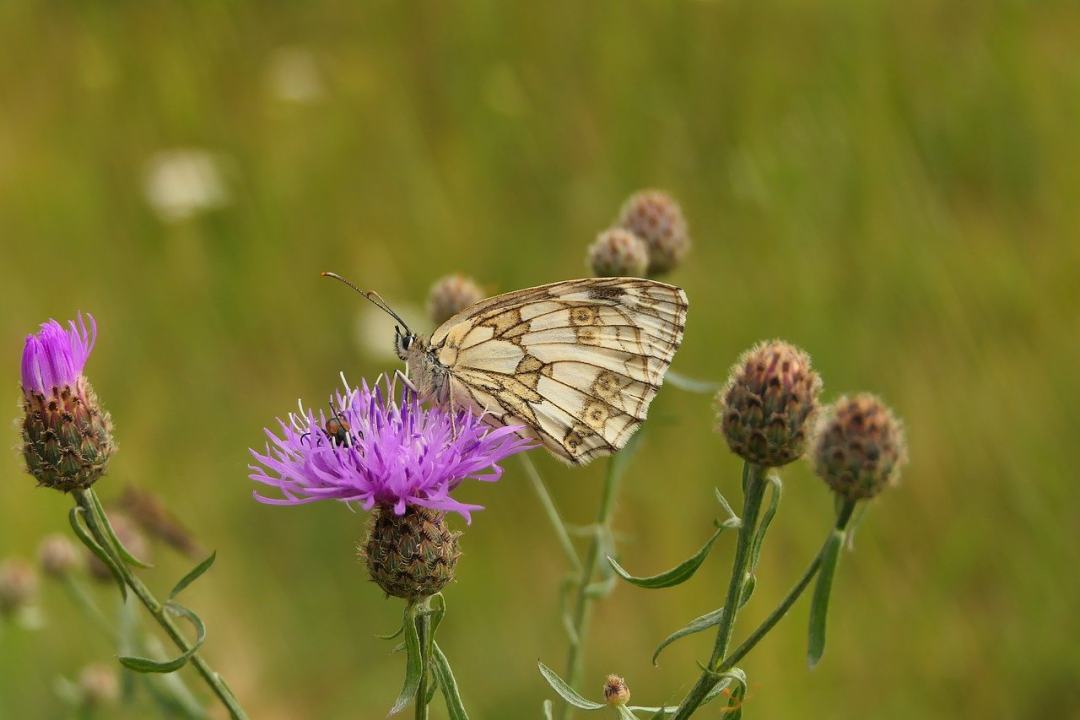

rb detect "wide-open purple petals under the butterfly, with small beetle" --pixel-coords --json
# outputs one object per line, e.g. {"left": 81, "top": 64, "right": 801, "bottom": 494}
{"left": 249, "top": 381, "right": 534, "bottom": 521}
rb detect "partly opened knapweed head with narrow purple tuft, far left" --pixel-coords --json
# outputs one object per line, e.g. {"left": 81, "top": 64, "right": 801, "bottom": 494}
{"left": 23, "top": 315, "right": 114, "bottom": 492}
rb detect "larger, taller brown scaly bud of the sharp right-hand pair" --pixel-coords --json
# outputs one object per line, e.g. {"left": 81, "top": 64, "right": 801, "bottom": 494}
{"left": 716, "top": 340, "right": 821, "bottom": 467}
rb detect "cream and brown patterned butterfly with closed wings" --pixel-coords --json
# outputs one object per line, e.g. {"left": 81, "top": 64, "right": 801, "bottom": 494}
{"left": 323, "top": 273, "right": 687, "bottom": 465}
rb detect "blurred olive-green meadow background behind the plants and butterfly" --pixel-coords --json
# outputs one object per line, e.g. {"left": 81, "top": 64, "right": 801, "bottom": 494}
{"left": 0, "top": 0, "right": 1080, "bottom": 719}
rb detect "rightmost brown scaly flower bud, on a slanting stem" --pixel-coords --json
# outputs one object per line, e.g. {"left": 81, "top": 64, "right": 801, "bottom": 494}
{"left": 811, "top": 393, "right": 907, "bottom": 501}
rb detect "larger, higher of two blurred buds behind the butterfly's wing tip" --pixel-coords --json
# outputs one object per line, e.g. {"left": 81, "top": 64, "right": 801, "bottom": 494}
{"left": 618, "top": 190, "right": 690, "bottom": 276}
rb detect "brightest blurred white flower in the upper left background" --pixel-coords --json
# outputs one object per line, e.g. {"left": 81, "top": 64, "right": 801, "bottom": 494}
{"left": 143, "top": 148, "right": 230, "bottom": 222}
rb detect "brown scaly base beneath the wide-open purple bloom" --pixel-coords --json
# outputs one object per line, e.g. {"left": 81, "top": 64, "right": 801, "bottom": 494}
{"left": 361, "top": 505, "right": 461, "bottom": 602}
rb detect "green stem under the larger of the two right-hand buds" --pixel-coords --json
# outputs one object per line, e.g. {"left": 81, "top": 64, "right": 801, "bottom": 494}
{"left": 674, "top": 462, "right": 767, "bottom": 720}
